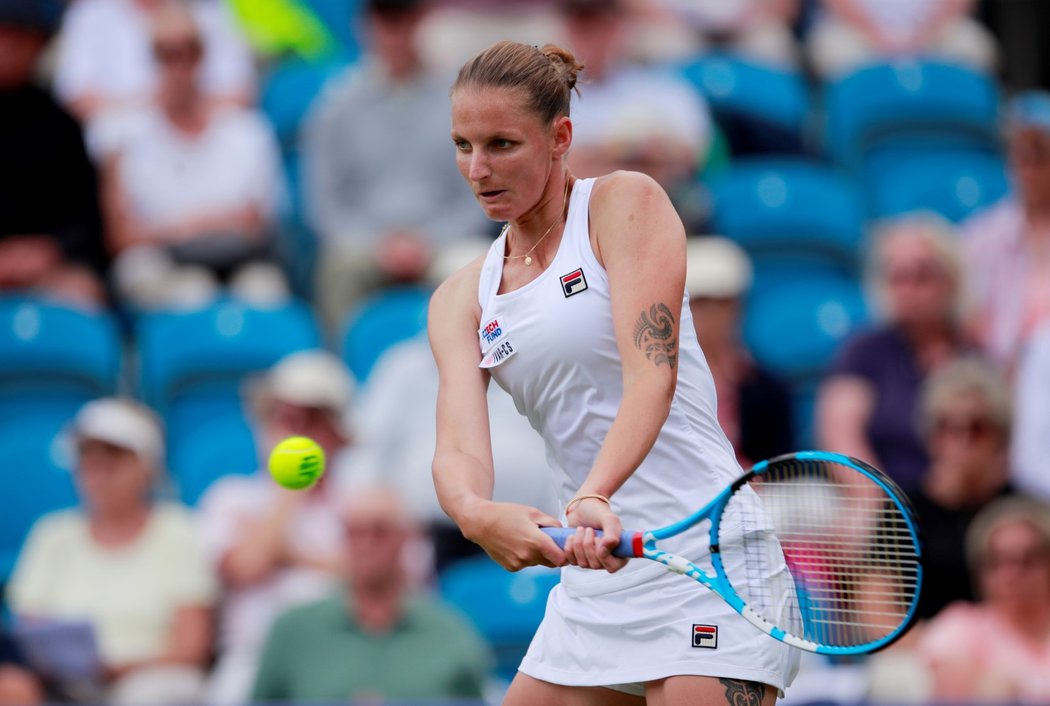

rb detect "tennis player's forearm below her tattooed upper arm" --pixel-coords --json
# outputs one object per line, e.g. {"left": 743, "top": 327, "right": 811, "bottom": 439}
{"left": 578, "top": 371, "right": 674, "bottom": 497}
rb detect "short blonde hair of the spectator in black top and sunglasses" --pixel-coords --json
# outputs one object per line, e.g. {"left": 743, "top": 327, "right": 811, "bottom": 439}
{"left": 919, "top": 356, "right": 1013, "bottom": 441}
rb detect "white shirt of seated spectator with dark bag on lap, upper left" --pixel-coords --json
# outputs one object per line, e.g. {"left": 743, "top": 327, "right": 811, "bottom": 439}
{"left": 89, "top": 106, "right": 285, "bottom": 233}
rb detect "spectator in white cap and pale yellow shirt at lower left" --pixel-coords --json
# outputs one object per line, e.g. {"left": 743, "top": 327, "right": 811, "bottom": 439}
{"left": 9, "top": 398, "right": 216, "bottom": 706}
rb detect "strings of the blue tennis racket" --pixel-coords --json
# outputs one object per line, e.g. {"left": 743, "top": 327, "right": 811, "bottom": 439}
{"left": 719, "top": 460, "right": 921, "bottom": 646}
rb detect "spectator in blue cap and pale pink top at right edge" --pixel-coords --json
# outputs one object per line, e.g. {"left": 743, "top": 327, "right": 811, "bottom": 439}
{"left": 963, "top": 91, "right": 1050, "bottom": 369}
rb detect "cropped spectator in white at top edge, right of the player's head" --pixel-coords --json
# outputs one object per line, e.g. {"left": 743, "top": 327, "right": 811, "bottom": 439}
{"left": 662, "top": 0, "right": 799, "bottom": 67}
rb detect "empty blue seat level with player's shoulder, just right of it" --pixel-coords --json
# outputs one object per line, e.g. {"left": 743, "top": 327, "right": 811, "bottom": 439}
{"left": 709, "top": 159, "right": 864, "bottom": 273}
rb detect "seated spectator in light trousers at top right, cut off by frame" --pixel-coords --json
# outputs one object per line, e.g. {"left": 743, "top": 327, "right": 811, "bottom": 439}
{"left": 809, "top": 0, "right": 998, "bottom": 79}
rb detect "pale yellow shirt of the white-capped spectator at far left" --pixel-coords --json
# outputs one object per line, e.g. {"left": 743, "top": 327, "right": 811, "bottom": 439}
{"left": 7, "top": 504, "right": 217, "bottom": 664}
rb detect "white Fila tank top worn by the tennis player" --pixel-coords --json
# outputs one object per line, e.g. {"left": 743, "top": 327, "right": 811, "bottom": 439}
{"left": 478, "top": 179, "right": 740, "bottom": 596}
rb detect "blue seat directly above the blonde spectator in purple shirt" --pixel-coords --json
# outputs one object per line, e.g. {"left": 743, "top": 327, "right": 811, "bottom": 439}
{"left": 864, "top": 152, "right": 1010, "bottom": 223}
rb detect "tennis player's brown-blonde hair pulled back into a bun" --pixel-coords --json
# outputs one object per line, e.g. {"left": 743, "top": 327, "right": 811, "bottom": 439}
{"left": 450, "top": 40, "right": 584, "bottom": 123}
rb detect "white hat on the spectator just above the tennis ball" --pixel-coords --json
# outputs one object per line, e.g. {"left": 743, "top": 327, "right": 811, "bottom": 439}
{"left": 258, "top": 349, "right": 354, "bottom": 430}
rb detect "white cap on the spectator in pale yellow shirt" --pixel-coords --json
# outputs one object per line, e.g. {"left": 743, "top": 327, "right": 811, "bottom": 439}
{"left": 72, "top": 397, "right": 164, "bottom": 470}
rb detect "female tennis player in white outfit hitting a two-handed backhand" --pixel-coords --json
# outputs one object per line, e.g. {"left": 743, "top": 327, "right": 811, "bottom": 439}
{"left": 428, "top": 42, "right": 796, "bottom": 706}
